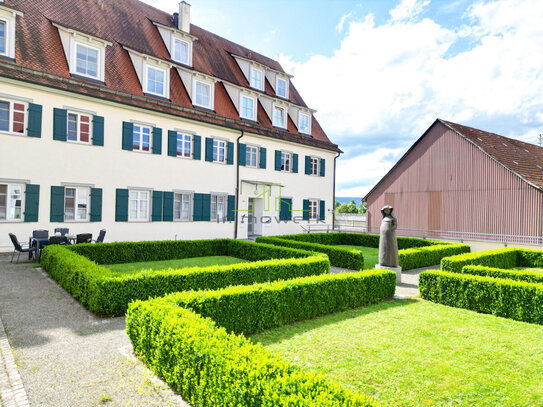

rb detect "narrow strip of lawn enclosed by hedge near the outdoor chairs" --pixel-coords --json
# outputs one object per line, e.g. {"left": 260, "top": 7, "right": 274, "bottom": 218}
{"left": 106, "top": 256, "right": 247, "bottom": 274}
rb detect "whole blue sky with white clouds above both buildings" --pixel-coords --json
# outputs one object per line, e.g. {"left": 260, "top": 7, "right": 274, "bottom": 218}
{"left": 140, "top": 0, "right": 543, "bottom": 197}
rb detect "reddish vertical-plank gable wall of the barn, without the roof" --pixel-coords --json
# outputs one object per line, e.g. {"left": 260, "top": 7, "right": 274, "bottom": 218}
{"left": 367, "top": 122, "right": 543, "bottom": 241}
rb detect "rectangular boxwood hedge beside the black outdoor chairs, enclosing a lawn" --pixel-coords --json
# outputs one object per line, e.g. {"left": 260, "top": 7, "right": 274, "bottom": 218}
{"left": 41, "top": 239, "right": 330, "bottom": 315}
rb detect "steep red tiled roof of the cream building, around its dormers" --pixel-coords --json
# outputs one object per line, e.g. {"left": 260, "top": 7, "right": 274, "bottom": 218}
{"left": 0, "top": 0, "right": 340, "bottom": 151}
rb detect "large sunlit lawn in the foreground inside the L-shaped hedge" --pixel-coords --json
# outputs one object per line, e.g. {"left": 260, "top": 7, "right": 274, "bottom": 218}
{"left": 252, "top": 300, "right": 543, "bottom": 406}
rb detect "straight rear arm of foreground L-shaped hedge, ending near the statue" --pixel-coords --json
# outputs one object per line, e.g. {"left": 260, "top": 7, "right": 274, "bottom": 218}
{"left": 169, "top": 270, "right": 396, "bottom": 334}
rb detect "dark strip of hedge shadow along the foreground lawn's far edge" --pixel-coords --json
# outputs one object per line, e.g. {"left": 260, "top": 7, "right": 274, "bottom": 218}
{"left": 251, "top": 299, "right": 419, "bottom": 346}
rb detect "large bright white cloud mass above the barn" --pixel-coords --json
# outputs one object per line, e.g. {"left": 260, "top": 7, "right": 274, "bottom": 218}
{"left": 279, "top": 0, "right": 543, "bottom": 193}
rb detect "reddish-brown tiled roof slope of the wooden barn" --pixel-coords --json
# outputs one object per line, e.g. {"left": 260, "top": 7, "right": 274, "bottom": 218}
{"left": 438, "top": 119, "right": 543, "bottom": 189}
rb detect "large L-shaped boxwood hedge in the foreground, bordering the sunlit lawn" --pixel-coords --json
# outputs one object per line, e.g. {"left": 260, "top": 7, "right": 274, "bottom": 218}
{"left": 126, "top": 270, "right": 396, "bottom": 407}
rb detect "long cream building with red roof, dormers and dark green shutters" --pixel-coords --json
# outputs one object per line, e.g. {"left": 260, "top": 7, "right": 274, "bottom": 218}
{"left": 0, "top": 0, "right": 340, "bottom": 248}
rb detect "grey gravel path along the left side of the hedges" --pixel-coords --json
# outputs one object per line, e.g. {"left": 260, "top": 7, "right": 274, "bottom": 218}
{"left": 0, "top": 254, "right": 188, "bottom": 407}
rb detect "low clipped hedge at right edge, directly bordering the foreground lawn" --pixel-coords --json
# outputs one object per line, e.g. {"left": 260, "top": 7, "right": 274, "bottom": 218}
{"left": 419, "top": 270, "right": 543, "bottom": 324}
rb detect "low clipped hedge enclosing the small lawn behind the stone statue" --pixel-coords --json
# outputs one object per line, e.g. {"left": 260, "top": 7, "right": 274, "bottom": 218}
{"left": 257, "top": 233, "right": 470, "bottom": 270}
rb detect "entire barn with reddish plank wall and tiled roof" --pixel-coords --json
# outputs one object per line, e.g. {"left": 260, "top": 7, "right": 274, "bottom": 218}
{"left": 363, "top": 119, "right": 543, "bottom": 245}
